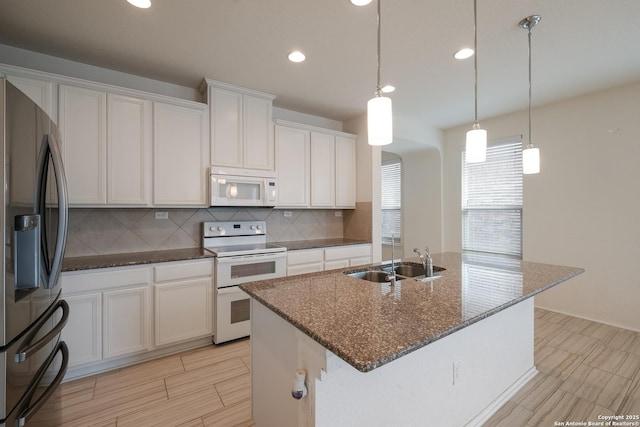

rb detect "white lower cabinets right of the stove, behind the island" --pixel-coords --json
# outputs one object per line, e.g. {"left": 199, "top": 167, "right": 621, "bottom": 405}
{"left": 287, "top": 243, "right": 371, "bottom": 276}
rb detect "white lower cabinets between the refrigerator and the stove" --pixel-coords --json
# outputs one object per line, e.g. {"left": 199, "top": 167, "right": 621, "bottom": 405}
{"left": 61, "top": 259, "right": 213, "bottom": 379}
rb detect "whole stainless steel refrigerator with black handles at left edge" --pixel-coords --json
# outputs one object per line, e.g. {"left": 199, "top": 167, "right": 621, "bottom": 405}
{"left": 0, "top": 79, "right": 69, "bottom": 427}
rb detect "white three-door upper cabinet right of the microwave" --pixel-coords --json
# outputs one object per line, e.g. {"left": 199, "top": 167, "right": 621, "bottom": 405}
{"left": 276, "top": 120, "right": 356, "bottom": 209}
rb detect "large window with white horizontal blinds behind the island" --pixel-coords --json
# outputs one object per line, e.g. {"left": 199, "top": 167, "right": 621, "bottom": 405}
{"left": 462, "top": 138, "right": 522, "bottom": 258}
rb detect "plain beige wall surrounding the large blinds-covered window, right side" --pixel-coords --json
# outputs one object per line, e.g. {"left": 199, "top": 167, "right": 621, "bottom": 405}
{"left": 443, "top": 82, "right": 640, "bottom": 330}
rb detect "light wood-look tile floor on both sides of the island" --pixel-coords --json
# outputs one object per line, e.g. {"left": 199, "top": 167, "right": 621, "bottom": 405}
{"left": 57, "top": 309, "right": 640, "bottom": 427}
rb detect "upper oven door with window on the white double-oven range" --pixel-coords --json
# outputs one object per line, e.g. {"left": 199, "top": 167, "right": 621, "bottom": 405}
{"left": 215, "top": 252, "right": 287, "bottom": 289}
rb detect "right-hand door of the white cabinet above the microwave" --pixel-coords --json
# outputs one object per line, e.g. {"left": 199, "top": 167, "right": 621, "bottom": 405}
{"left": 243, "top": 95, "right": 274, "bottom": 171}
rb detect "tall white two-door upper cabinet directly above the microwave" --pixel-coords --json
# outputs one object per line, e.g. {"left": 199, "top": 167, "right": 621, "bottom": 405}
{"left": 201, "top": 79, "right": 275, "bottom": 171}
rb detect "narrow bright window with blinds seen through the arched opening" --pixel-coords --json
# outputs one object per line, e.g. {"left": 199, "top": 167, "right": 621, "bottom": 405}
{"left": 380, "top": 158, "right": 402, "bottom": 244}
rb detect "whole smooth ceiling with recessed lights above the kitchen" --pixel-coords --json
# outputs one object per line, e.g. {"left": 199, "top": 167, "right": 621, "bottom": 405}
{"left": 0, "top": 0, "right": 640, "bottom": 129}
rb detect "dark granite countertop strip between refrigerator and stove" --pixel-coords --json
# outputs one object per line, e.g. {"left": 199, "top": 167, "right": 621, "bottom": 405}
{"left": 62, "top": 248, "right": 213, "bottom": 271}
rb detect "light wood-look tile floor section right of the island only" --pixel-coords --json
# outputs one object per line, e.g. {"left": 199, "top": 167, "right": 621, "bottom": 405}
{"left": 484, "top": 309, "right": 640, "bottom": 427}
